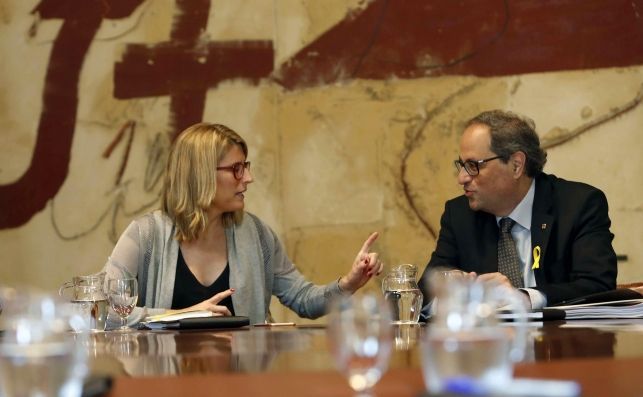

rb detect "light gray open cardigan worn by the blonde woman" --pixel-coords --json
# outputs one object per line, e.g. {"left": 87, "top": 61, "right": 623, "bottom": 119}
{"left": 104, "top": 211, "right": 341, "bottom": 324}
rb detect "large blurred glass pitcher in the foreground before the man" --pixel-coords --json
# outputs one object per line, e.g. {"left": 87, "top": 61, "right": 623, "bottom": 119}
{"left": 421, "top": 275, "right": 527, "bottom": 395}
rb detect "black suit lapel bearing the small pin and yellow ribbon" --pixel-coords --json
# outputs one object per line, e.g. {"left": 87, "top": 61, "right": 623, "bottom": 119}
{"left": 531, "top": 173, "right": 554, "bottom": 285}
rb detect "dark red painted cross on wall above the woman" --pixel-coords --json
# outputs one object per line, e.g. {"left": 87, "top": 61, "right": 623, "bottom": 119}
{"left": 114, "top": 0, "right": 274, "bottom": 135}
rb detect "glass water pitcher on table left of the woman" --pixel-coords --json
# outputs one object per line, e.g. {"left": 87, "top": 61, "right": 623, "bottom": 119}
{"left": 58, "top": 273, "right": 109, "bottom": 331}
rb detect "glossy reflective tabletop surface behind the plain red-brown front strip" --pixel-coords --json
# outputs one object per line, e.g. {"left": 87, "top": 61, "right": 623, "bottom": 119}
{"left": 86, "top": 322, "right": 643, "bottom": 377}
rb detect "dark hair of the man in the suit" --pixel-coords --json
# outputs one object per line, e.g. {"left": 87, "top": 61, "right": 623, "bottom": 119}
{"left": 465, "top": 110, "right": 547, "bottom": 178}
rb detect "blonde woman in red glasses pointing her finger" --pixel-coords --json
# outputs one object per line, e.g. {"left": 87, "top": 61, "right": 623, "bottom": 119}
{"left": 105, "top": 123, "right": 382, "bottom": 323}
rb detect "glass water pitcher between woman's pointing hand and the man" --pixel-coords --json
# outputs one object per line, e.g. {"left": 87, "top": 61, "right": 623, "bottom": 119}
{"left": 382, "top": 264, "right": 422, "bottom": 324}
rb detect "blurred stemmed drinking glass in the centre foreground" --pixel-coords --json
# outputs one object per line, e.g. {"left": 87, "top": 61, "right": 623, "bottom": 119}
{"left": 328, "top": 294, "right": 393, "bottom": 396}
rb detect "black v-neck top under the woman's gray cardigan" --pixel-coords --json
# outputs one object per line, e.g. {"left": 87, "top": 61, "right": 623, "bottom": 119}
{"left": 172, "top": 249, "right": 234, "bottom": 316}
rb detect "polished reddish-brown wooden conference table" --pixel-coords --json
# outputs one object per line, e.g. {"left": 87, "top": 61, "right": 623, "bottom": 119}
{"left": 84, "top": 320, "right": 643, "bottom": 397}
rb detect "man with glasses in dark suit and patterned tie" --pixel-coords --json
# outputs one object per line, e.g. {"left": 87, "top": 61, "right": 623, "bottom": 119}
{"left": 420, "top": 110, "right": 617, "bottom": 309}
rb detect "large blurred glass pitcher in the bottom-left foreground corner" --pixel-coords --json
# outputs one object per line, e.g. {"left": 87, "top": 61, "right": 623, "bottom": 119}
{"left": 0, "top": 288, "right": 87, "bottom": 397}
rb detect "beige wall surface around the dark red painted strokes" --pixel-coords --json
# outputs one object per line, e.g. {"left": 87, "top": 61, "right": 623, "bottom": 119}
{"left": 0, "top": 0, "right": 643, "bottom": 320}
